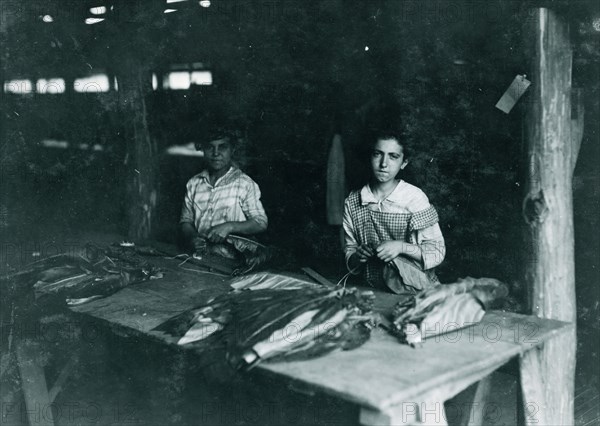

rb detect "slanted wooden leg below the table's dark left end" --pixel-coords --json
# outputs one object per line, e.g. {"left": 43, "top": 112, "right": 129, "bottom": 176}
{"left": 16, "top": 340, "right": 54, "bottom": 426}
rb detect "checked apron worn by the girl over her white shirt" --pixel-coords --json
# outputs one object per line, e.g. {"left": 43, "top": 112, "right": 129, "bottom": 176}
{"left": 348, "top": 191, "right": 439, "bottom": 293}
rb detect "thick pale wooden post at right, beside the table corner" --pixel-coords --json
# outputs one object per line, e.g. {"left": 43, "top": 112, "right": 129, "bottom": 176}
{"left": 521, "top": 8, "right": 582, "bottom": 425}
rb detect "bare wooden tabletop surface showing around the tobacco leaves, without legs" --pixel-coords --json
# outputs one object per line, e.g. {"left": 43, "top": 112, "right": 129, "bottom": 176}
{"left": 68, "top": 256, "right": 565, "bottom": 416}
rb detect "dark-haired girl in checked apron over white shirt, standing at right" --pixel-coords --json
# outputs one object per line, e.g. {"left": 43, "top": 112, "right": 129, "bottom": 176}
{"left": 343, "top": 134, "right": 446, "bottom": 293}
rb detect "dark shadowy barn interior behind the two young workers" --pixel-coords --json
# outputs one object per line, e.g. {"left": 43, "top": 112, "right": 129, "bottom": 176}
{"left": 0, "top": 0, "right": 600, "bottom": 390}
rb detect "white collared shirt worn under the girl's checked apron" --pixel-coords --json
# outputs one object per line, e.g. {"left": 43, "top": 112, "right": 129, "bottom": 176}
{"left": 343, "top": 180, "right": 446, "bottom": 270}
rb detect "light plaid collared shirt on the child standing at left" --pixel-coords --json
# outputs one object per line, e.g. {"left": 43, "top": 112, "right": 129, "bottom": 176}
{"left": 179, "top": 166, "right": 267, "bottom": 236}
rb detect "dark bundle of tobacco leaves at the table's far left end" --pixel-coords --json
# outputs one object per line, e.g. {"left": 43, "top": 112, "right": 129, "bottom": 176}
{"left": 7, "top": 244, "right": 162, "bottom": 305}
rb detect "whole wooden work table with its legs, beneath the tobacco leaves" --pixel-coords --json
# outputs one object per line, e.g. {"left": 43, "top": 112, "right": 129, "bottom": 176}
{"left": 62, "top": 251, "right": 572, "bottom": 425}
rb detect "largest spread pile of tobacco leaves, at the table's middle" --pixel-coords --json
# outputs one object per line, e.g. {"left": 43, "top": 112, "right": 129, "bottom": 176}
{"left": 156, "top": 277, "right": 378, "bottom": 369}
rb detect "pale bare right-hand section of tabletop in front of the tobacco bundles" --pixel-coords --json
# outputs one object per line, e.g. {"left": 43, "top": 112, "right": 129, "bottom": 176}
{"left": 261, "top": 313, "right": 570, "bottom": 411}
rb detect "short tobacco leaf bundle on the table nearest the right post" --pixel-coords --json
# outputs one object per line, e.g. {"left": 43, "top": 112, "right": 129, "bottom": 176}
{"left": 392, "top": 277, "right": 508, "bottom": 345}
